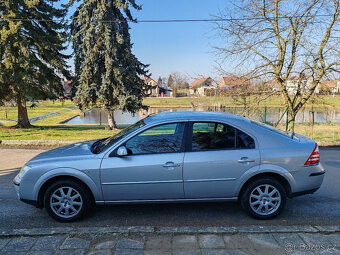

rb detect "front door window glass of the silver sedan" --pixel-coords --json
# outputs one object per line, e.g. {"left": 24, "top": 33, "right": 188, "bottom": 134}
{"left": 126, "top": 123, "right": 185, "bottom": 155}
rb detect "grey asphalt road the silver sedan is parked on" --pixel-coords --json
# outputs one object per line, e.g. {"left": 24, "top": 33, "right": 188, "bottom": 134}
{"left": 0, "top": 148, "right": 340, "bottom": 230}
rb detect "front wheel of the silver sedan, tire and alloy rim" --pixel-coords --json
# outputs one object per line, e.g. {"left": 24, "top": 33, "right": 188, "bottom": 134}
{"left": 44, "top": 180, "right": 93, "bottom": 222}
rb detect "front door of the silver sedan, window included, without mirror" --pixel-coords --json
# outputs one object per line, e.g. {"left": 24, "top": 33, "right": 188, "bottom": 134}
{"left": 101, "top": 122, "right": 186, "bottom": 201}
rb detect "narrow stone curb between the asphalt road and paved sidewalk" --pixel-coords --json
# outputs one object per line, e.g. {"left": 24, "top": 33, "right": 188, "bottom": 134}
{"left": 0, "top": 225, "right": 340, "bottom": 237}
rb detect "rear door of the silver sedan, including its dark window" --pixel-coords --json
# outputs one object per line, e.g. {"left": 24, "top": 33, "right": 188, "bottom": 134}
{"left": 183, "top": 122, "right": 260, "bottom": 199}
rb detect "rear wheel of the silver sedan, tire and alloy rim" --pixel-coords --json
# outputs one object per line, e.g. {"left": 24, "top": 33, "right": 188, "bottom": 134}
{"left": 240, "top": 177, "right": 287, "bottom": 220}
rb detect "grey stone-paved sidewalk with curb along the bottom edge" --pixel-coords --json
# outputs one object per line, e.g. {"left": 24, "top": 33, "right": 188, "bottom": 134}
{"left": 0, "top": 226, "right": 340, "bottom": 255}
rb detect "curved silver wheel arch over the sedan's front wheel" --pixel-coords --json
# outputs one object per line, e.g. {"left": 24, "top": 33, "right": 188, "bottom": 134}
{"left": 32, "top": 168, "right": 103, "bottom": 201}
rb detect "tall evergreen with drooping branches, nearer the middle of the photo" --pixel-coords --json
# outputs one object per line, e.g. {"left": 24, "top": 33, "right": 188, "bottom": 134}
{"left": 70, "top": 0, "right": 148, "bottom": 129}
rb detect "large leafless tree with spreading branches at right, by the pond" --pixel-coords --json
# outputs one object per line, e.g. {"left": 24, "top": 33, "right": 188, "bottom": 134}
{"left": 216, "top": 0, "right": 340, "bottom": 131}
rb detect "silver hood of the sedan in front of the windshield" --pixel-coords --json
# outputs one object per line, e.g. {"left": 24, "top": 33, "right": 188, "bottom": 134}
{"left": 27, "top": 140, "right": 96, "bottom": 164}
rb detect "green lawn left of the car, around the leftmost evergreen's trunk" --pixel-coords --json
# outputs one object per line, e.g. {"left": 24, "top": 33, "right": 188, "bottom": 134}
{"left": 0, "top": 100, "right": 117, "bottom": 141}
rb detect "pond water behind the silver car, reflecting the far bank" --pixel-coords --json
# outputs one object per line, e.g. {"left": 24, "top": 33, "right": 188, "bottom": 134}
{"left": 66, "top": 107, "right": 340, "bottom": 126}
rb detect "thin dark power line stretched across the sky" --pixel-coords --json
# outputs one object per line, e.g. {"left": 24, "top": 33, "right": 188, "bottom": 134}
{"left": 3, "top": 14, "right": 333, "bottom": 24}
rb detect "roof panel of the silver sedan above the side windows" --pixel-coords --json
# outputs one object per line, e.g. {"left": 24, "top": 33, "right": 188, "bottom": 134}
{"left": 144, "top": 111, "right": 249, "bottom": 124}
